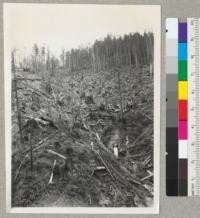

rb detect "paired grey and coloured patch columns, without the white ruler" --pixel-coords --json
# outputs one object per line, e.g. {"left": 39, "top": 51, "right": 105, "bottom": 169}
{"left": 166, "top": 18, "right": 188, "bottom": 196}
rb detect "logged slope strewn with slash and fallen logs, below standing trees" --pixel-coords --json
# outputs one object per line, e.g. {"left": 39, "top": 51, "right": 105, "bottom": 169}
{"left": 12, "top": 66, "right": 154, "bottom": 207}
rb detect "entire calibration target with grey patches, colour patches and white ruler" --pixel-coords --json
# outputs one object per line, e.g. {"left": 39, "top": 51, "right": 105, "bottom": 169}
{"left": 166, "top": 18, "right": 200, "bottom": 196}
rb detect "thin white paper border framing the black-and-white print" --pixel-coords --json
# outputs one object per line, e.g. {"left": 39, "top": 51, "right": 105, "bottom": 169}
{"left": 3, "top": 3, "right": 161, "bottom": 214}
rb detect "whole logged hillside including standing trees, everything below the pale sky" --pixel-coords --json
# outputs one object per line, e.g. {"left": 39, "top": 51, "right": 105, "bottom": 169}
{"left": 12, "top": 32, "right": 154, "bottom": 207}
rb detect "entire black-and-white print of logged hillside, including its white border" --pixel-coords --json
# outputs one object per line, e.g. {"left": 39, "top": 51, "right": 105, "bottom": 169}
{"left": 4, "top": 3, "right": 161, "bottom": 214}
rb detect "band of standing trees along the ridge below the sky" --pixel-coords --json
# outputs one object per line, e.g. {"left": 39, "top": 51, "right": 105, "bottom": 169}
{"left": 20, "top": 33, "right": 154, "bottom": 74}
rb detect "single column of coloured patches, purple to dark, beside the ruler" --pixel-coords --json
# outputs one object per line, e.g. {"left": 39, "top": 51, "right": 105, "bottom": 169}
{"left": 178, "top": 22, "right": 188, "bottom": 196}
